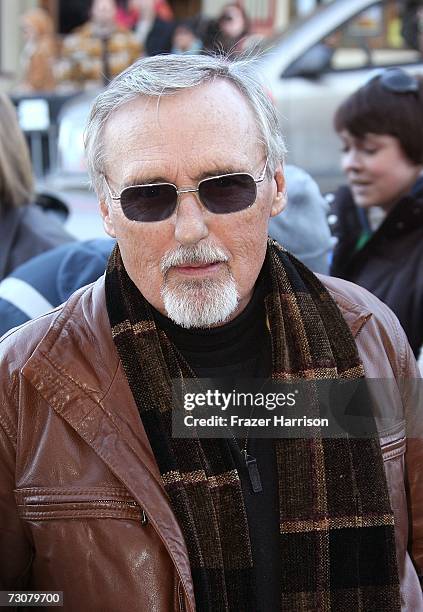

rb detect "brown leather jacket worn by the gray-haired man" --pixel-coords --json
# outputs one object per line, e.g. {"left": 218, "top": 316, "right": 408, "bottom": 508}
{"left": 0, "top": 278, "right": 423, "bottom": 612}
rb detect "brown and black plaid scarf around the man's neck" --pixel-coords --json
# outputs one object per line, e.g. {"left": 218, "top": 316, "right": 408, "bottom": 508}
{"left": 106, "top": 241, "right": 400, "bottom": 612}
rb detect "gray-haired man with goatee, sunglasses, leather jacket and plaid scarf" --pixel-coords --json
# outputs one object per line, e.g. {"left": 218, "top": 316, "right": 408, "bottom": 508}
{"left": 0, "top": 56, "right": 423, "bottom": 612}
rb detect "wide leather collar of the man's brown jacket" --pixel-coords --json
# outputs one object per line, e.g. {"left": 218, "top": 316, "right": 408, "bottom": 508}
{"left": 22, "top": 276, "right": 370, "bottom": 610}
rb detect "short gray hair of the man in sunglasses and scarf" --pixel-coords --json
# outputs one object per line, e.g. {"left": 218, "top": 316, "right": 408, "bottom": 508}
{"left": 85, "top": 55, "right": 285, "bottom": 197}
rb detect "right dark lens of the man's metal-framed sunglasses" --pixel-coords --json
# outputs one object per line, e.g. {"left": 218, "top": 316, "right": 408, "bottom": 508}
{"left": 198, "top": 174, "right": 257, "bottom": 214}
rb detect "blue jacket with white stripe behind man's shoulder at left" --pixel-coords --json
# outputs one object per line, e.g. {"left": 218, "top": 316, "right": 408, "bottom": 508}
{"left": 0, "top": 238, "right": 115, "bottom": 336}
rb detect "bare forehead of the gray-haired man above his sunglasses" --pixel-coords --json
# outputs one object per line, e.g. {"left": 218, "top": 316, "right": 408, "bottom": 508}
{"left": 104, "top": 79, "right": 260, "bottom": 172}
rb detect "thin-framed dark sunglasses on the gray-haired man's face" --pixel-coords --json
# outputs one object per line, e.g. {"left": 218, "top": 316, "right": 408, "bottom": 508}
{"left": 104, "top": 159, "right": 268, "bottom": 223}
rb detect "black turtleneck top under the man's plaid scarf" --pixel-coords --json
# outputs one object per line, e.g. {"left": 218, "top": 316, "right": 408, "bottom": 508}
{"left": 153, "top": 280, "right": 281, "bottom": 612}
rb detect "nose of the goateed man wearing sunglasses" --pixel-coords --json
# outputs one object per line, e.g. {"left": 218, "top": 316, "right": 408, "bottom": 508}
{"left": 175, "top": 193, "right": 209, "bottom": 246}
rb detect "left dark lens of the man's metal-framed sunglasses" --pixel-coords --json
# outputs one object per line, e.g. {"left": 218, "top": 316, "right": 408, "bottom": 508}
{"left": 120, "top": 184, "right": 177, "bottom": 223}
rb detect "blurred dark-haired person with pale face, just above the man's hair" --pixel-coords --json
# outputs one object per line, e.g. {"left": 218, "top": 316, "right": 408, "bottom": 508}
{"left": 204, "top": 2, "right": 250, "bottom": 55}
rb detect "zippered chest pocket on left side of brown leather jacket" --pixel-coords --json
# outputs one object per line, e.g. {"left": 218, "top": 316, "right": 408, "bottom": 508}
{"left": 14, "top": 487, "right": 148, "bottom": 525}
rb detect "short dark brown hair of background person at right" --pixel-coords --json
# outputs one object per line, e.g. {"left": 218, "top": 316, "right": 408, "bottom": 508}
{"left": 334, "top": 76, "right": 423, "bottom": 164}
